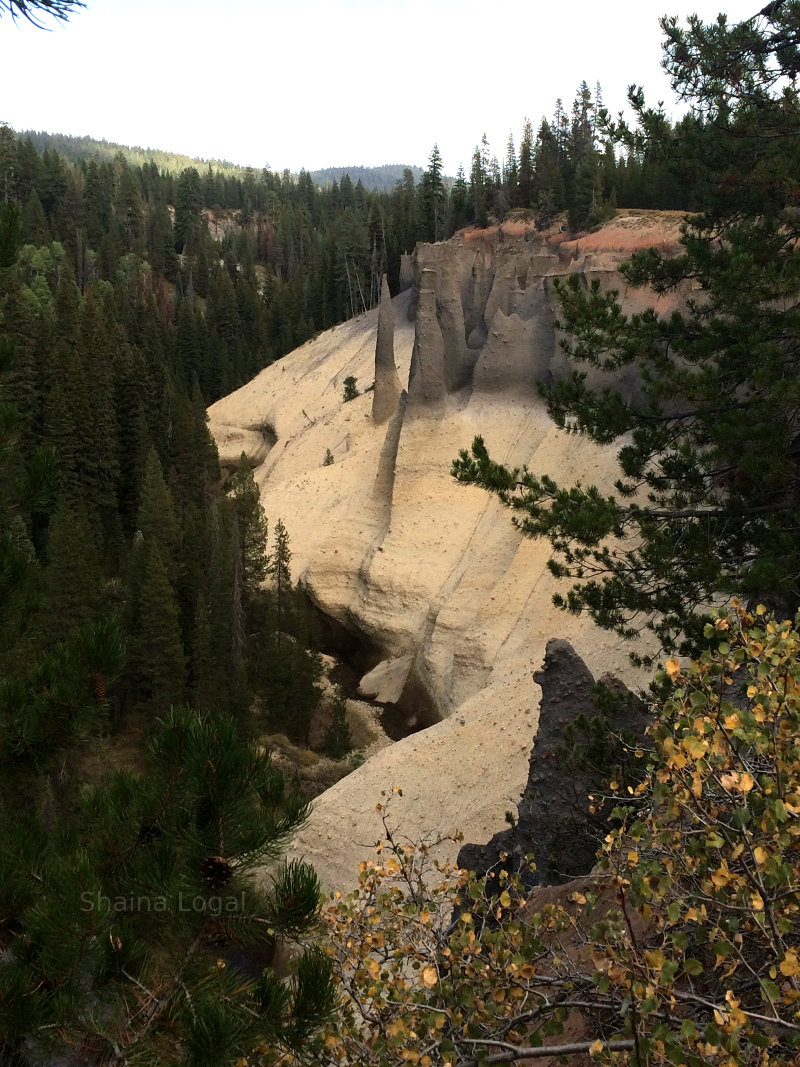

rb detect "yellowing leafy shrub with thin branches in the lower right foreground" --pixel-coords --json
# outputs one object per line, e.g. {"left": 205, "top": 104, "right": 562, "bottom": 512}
{"left": 307, "top": 601, "right": 800, "bottom": 1067}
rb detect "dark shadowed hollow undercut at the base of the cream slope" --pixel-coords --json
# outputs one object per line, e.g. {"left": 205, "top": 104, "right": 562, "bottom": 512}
{"left": 306, "top": 593, "right": 442, "bottom": 740}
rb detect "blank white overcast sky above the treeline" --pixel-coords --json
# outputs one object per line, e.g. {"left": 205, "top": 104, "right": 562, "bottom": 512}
{"left": 0, "top": 0, "right": 763, "bottom": 174}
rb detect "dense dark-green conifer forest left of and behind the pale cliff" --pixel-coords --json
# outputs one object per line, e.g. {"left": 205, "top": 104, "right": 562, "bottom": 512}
{"left": 0, "top": 43, "right": 763, "bottom": 1067}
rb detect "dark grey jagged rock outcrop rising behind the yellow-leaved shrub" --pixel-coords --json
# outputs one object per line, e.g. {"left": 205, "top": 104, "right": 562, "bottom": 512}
{"left": 458, "top": 638, "right": 650, "bottom": 885}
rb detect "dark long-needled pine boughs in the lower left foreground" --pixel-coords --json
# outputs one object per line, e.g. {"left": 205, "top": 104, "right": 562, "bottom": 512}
{"left": 0, "top": 708, "right": 334, "bottom": 1067}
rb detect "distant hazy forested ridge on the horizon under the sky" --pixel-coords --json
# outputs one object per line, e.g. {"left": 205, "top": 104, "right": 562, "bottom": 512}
{"left": 18, "top": 130, "right": 422, "bottom": 192}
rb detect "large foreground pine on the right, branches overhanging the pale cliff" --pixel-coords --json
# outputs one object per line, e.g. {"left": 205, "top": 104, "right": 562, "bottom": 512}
{"left": 455, "top": 3, "right": 800, "bottom": 649}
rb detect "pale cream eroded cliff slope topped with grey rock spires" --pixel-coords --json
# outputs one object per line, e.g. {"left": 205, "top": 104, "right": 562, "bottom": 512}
{"left": 209, "top": 212, "right": 683, "bottom": 886}
